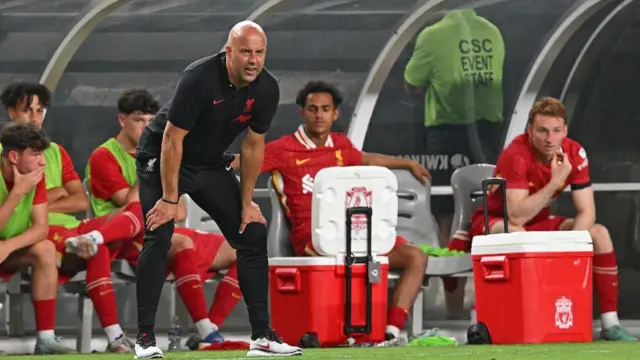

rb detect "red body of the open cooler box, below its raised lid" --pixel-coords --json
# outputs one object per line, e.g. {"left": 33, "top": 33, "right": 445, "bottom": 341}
{"left": 269, "top": 256, "right": 389, "bottom": 347}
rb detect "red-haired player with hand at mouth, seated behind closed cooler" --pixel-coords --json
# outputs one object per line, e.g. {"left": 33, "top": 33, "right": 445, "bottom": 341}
{"left": 471, "top": 97, "right": 637, "bottom": 341}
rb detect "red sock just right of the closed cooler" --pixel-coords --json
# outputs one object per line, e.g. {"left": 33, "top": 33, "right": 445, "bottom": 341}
{"left": 593, "top": 251, "right": 618, "bottom": 313}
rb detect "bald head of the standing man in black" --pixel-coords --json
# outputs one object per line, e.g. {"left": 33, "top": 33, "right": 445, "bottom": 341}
{"left": 225, "top": 21, "right": 267, "bottom": 87}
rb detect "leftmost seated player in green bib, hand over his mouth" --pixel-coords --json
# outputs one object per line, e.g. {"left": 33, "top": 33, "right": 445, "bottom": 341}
{"left": 0, "top": 123, "right": 73, "bottom": 355}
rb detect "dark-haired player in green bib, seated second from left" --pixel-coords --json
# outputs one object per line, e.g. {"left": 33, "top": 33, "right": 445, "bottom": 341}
{"left": 2, "top": 82, "right": 140, "bottom": 352}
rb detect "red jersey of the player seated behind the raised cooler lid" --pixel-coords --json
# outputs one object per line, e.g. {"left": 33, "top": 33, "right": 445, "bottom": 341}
{"left": 260, "top": 126, "right": 362, "bottom": 254}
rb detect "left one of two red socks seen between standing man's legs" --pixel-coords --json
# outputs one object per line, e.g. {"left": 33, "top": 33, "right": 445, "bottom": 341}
{"left": 172, "top": 249, "right": 207, "bottom": 323}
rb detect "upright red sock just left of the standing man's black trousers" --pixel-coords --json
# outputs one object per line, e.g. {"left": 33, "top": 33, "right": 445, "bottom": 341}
{"left": 86, "top": 245, "right": 118, "bottom": 328}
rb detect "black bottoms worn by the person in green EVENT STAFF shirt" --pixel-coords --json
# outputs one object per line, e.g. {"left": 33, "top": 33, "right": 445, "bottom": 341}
{"left": 419, "top": 120, "right": 503, "bottom": 216}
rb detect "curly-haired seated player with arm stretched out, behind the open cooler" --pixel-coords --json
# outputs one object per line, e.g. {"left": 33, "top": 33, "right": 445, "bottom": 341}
{"left": 232, "top": 81, "right": 430, "bottom": 340}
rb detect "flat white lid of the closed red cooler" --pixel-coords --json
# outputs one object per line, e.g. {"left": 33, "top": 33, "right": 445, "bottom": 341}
{"left": 471, "top": 230, "right": 593, "bottom": 255}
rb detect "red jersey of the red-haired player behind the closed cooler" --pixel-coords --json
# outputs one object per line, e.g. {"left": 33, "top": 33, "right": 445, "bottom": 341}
{"left": 478, "top": 134, "right": 591, "bottom": 223}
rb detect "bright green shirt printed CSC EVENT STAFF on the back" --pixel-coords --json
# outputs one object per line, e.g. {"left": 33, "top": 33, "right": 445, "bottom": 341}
{"left": 404, "top": 9, "right": 505, "bottom": 126}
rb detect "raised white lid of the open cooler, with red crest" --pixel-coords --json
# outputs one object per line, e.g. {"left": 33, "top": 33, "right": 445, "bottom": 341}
{"left": 311, "top": 166, "right": 398, "bottom": 256}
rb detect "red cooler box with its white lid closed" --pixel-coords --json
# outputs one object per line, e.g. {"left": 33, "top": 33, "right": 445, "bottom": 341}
{"left": 471, "top": 231, "right": 593, "bottom": 344}
